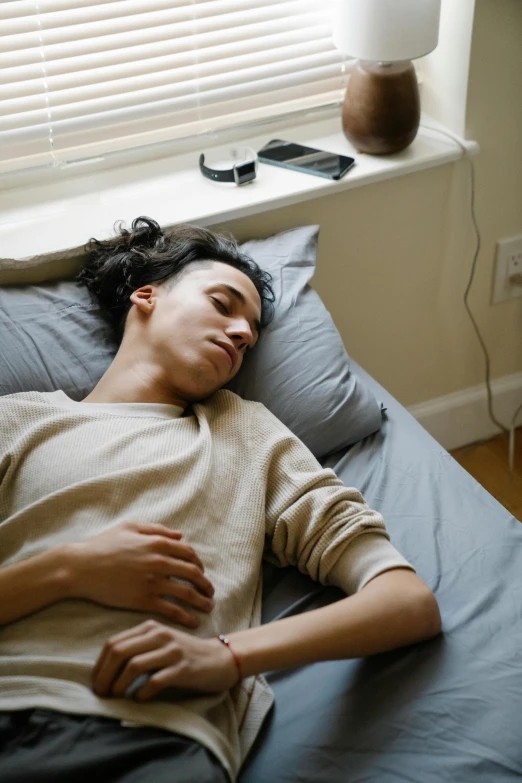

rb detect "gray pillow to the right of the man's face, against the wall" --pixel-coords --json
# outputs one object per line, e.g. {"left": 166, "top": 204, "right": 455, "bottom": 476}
{"left": 221, "top": 226, "right": 382, "bottom": 459}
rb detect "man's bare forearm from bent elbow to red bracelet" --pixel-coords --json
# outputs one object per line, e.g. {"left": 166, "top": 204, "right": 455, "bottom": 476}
{"left": 228, "top": 569, "right": 440, "bottom": 677}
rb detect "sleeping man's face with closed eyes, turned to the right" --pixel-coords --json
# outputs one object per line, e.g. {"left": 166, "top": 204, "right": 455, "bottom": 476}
{"left": 126, "top": 261, "right": 261, "bottom": 404}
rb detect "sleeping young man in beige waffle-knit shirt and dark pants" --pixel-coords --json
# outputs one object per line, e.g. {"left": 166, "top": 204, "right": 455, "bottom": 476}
{"left": 0, "top": 218, "right": 441, "bottom": 783}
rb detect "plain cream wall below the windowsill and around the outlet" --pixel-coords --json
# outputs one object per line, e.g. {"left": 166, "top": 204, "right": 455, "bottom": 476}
{"left": 211, "top": 0, "right": 522, "bottom": 414}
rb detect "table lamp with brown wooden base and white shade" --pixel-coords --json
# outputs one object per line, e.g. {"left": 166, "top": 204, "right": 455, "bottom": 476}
{"left": 333, "top": 0, "right": 441, "bottom": 155}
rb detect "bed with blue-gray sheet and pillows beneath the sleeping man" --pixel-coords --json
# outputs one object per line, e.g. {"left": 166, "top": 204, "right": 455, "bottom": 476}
{"left": 0, "top": 222, "right": 522, "bottom": 783}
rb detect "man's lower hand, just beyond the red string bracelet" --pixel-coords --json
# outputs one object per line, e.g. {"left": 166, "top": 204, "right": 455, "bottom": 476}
{"left": 92, "top": 620, "right": 239, "bottom": 701}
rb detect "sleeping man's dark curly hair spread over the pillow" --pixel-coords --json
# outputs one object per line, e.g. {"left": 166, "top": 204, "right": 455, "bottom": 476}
{"left": 76, "top": 217, "right": 275, "bottom": 341}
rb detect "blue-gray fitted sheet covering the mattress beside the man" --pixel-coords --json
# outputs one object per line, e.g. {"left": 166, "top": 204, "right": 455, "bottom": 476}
{"left": 239, "top": 365, "right": 522, "bottom": 783}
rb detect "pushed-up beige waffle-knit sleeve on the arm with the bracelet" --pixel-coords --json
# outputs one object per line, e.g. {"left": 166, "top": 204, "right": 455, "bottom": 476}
{"left": 256, "top": 405, "right": 415, "bottom": 594}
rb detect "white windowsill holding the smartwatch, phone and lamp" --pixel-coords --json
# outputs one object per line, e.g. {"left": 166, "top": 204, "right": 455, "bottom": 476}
{"left": 0, "top": 108, "right": 479, "bottom": 269}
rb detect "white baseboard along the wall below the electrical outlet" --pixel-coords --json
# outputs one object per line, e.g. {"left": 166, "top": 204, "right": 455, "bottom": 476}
{"left": 408, "top": 373, "right": 522, "bottom": 451}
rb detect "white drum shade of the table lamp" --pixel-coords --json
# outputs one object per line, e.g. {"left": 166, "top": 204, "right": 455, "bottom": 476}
{"left": 333, "top": 0, "right": 441, "bottom": 62}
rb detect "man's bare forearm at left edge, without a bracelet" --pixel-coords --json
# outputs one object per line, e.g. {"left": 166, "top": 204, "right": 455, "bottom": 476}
{"left": 0, "top": 546, "right": 70, "bottom": 625}
